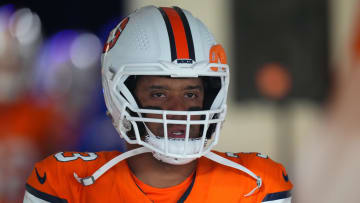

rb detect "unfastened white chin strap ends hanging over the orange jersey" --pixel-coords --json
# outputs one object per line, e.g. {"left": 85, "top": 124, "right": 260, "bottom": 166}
{"left": 74, "top": 147, "right": 262, "bottom": 197}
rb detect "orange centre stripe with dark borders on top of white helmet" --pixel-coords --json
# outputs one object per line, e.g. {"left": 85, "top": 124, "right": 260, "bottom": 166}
{"left": 159, "top": 7, "right": 195, "bottom": 61}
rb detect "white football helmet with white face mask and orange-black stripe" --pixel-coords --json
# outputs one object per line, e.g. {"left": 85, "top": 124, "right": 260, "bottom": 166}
{"left": 101, "top": 6, "right": 229, "bottom": 164}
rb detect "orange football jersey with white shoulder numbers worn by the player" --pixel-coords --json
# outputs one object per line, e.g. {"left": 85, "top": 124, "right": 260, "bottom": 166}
{"left": 25, "top": 151, "right": 292, "bottom": 203}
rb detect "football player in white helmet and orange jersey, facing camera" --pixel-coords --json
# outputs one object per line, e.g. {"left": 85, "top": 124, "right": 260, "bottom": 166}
{"left": 24, "top": 6, "right": 292, "bottom": 203}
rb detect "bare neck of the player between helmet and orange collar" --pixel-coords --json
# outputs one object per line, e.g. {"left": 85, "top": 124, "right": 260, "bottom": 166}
{"left": 127, "top": 149, "right": 197, "bottom": 188}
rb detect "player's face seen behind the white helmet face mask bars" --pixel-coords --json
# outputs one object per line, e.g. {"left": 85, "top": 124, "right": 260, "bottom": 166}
{"left": 135, "top": 76, "right": 204, "bottom": 138}
